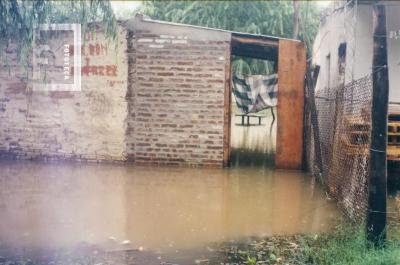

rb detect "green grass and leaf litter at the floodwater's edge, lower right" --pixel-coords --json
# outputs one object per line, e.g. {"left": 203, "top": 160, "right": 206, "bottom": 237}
{"left": 217, "top": 224, "right": 400, "bottom": 265}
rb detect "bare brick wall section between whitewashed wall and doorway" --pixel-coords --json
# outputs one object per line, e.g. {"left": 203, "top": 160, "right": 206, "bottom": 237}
{"left": 128, "top": 18, "right": 230, "bottom": 166}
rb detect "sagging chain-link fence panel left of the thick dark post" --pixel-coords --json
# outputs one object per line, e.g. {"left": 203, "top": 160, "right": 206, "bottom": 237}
{"left": 305, "top": 75, "right": 372, "bottom": 220}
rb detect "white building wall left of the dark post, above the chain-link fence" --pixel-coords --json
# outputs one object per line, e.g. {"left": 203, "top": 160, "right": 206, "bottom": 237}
{"left": 313, "top": 5, "right": 373, "bottom": 90}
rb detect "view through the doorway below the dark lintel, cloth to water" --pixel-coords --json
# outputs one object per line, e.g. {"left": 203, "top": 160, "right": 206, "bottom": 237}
{"left": 230, "top": 55, "right": 278, "bottom": 168}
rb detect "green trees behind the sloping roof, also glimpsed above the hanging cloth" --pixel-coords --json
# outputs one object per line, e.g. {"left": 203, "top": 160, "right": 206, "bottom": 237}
{"left": 139, "top": 0, "right": 320, "bottom": 75}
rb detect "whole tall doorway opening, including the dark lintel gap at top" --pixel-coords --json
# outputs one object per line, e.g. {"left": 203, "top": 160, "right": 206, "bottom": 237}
{"left": 225, "top": 33, "right": 279, "bottom": 167}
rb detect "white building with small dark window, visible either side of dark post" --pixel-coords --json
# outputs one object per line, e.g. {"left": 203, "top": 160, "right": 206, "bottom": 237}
{"left": 313, "top": 0, "right": 400, "bottom": 112}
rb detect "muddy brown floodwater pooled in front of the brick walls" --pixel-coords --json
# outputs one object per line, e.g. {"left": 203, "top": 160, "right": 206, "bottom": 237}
{"left": 0, "top": 158, "right": 340, "bottom": 255}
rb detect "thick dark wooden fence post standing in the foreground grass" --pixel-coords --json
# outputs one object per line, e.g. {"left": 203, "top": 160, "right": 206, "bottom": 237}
{"left": 367, "top": 1, "right": 389, "bottom": 246}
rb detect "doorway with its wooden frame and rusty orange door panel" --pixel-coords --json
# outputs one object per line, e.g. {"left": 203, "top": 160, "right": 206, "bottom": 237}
{"left": 223, "top": 32, "right": 306, "bottom": 169}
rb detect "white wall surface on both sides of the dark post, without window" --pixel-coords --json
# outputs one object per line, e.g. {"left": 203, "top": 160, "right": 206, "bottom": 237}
{"left": 313, "top": 2, "right": 400, "bottom": 106}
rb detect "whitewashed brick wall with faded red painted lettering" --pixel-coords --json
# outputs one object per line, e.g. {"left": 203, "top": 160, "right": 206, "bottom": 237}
{"left": 0, "top": 24, "right": 128, "bottom": 161}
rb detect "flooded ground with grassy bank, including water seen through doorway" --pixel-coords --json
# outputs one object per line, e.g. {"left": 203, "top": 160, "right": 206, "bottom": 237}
{"left": 0, "top": 112, "right": 400, "bottom": 265}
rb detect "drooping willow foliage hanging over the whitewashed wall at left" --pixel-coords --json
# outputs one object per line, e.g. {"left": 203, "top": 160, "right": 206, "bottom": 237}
{"left": 0, "top": 0, "right": 117, "bottom": 59}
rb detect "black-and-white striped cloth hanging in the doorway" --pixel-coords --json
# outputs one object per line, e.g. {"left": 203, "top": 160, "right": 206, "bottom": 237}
{"left": 232, "top": 74, "right": 278, "bottom": 113}
